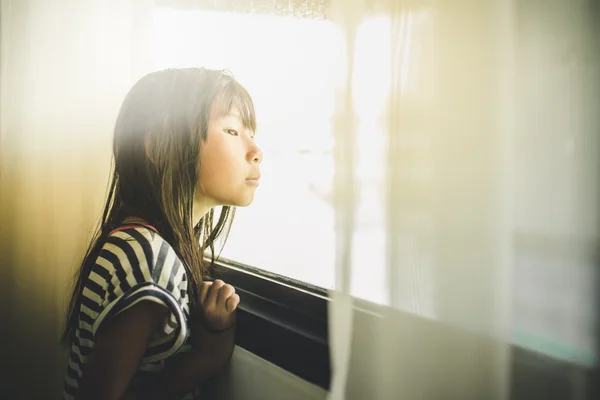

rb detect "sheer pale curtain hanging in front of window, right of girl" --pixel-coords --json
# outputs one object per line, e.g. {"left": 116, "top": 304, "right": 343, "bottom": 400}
{"left": 329, "top": 0, "right": 599, "bottom": 400}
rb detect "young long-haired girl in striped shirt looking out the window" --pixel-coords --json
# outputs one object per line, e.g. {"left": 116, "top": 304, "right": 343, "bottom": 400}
{"left": 63, "top": 68, "right": 262, "bottom": 400}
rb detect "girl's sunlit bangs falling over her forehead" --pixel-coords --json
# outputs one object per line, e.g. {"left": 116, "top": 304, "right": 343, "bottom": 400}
{"left": 212, "top": 80, "right": 256, "bottom": 132}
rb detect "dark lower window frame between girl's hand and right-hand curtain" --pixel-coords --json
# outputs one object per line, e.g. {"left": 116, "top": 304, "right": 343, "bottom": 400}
{"left": 213, "top": 259, "right": 331, "bottom": 390}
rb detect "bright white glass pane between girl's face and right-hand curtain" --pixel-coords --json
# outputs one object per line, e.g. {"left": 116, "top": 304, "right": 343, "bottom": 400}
{"left": 152, "top": 8, "right": 344, "bottom": 288}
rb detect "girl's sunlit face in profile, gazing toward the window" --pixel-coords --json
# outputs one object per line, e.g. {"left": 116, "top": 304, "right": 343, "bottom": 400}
{"left": 194, "top": 107, "right": 262, "bottom": 217}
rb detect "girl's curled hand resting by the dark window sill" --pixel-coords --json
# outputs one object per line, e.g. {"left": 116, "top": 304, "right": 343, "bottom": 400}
{"left": 198, "top": 279, "right": 240, "bottom": 331}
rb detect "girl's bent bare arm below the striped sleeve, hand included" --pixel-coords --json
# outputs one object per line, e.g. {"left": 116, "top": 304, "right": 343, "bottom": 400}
{"left": 77, "top": 281, "right": 239, "bottom": 400}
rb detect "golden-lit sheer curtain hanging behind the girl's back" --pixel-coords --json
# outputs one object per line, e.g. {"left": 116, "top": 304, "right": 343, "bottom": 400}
{"left": 0, "top": 0, "right": 152, "bottom": 399}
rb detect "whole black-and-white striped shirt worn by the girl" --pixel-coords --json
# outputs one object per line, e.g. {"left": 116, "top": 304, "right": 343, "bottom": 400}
{"left": 63, "top": 226, "right": 198, "bottom": 399}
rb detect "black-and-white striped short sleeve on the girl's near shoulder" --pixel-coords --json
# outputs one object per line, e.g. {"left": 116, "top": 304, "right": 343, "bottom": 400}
{"left": 92, "top": 228, "right": 188, "bottom": 362}
